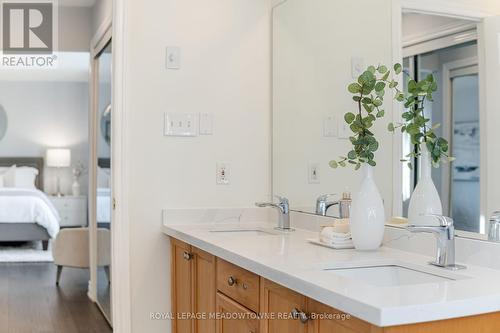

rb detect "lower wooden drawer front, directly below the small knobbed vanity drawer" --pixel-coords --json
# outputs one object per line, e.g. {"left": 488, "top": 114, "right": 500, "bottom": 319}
{"left": 216, "top": 293, "right": 259, "bottom": 333}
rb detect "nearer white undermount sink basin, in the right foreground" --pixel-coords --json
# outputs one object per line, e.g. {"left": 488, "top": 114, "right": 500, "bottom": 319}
{"left": 324, "top": 264, "right": 466, "bottom": 287}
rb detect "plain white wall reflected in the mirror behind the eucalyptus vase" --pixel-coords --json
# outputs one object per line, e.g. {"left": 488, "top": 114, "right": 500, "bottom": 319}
{"left": 273, "top": 0, "right": 393, "bottom": 216}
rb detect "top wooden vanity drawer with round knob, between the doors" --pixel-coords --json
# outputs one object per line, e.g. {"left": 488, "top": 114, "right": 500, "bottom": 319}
{"left": 217, "top": 258, "right": 260, "bottom": 312}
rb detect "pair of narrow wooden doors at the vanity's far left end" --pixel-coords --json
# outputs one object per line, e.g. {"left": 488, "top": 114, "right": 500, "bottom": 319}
{"left": 171, "top": 238, "right": 216, "bottom": 333}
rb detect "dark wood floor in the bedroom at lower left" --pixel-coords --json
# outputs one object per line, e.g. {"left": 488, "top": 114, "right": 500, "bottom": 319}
{"left": 0, "top": 263, "right": 112, "bottom": 333}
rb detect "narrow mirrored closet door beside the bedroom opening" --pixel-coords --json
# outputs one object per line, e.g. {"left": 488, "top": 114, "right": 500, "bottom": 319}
{"left": 96, "top": 42, "right": 112, "bottom": 320}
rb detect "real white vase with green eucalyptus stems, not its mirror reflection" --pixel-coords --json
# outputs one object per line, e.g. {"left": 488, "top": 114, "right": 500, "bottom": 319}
{"left": 330, "top": 64, "right": 404, "bottom": 250}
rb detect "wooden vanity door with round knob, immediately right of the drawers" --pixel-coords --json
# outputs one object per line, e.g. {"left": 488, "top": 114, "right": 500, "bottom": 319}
{"left": 260, "top": 279, "right": 309, "bottom": 333}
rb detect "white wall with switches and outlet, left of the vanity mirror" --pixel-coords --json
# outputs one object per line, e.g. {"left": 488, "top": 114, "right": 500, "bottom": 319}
{"left": 123, "top": 0, "right": 271, "bottom": 333}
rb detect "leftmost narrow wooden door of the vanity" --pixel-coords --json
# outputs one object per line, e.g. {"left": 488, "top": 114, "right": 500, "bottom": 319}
{"left": 170, "top": 238, "right": 194, "bottom": 333}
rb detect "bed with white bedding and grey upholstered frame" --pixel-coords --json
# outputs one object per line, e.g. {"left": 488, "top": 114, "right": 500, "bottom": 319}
{"left": 0, "top": 158, "right": 60, "bottom": 250}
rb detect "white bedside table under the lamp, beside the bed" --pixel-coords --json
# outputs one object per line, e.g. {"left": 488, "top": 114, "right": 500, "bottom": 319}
{"left": 49, "top": 195, "right": 87, "bottom": 228}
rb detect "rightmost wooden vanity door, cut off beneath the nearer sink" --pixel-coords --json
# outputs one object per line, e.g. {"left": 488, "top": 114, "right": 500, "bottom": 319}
{"left": 307, "top": 299, "right": 382, "bottom": 333}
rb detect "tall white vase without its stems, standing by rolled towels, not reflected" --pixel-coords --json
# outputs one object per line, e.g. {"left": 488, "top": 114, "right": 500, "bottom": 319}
{"left": 351, "top": 165, "right": 385, "bottom": 251}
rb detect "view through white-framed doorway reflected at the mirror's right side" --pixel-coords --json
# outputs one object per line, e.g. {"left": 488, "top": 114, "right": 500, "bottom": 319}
{"left": 402, "top": 13, "right": 485, "bottom": 234}
